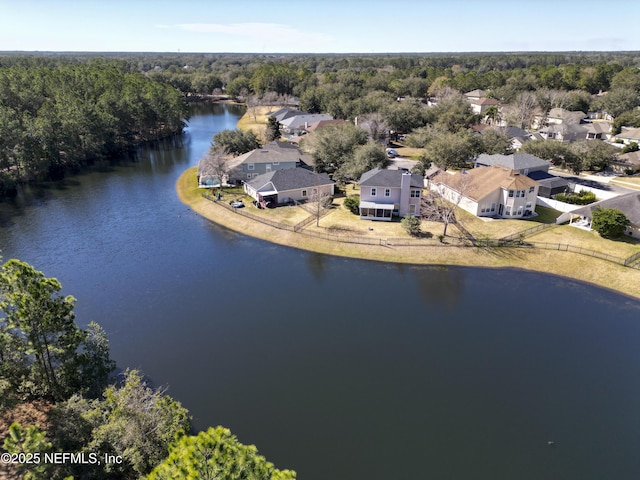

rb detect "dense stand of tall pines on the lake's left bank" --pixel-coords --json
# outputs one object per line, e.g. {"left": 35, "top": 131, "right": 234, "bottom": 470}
{"left": 0, "top": 57, "right": 188, "bottom": 195}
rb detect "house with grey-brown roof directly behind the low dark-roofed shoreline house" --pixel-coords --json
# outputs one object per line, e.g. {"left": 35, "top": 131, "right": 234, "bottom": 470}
{"left": 228, "top": 141, "right": 313, "bottom": 183}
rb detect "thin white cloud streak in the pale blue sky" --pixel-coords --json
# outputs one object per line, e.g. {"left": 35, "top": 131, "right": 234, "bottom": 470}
{"left": 156, "top": 23, "right": 331, "bottom": 48}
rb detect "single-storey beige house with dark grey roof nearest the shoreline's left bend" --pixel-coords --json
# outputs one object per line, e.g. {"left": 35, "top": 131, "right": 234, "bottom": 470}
{"left": 244, "top": 168, "right": 335, "bottom": 205}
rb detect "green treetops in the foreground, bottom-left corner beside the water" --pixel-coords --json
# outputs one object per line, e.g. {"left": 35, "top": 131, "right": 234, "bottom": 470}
{"left": 0, "top": 259, "right": 295, "bottom": 480}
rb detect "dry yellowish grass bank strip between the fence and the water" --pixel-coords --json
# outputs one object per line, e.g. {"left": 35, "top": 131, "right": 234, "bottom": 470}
{"left": 176, "top": 167, "right": 640, "bottom": 299}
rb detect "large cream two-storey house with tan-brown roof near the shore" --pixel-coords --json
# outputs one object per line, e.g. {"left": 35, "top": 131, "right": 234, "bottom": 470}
{"left": 431, "top": 165, "right": 539, "bottom": 219}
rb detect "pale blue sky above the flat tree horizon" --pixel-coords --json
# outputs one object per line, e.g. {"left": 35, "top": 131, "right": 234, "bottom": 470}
{"left": 0, "top": 0, "right": 640, "bottom": 53}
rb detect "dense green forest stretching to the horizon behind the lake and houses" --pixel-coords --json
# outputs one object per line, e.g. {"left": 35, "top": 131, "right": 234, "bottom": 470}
{"left": 5, "top": 52, "right": 640, "bottom": 195}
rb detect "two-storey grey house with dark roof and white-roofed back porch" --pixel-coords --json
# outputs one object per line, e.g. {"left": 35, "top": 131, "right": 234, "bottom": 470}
{"left": 358, "top": 168, "right": 424, "bottom": 222}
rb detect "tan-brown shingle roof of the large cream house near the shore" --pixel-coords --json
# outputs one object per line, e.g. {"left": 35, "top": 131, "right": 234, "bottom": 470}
{"left": 433, "top": 165, "right": 539, "bottom": 201}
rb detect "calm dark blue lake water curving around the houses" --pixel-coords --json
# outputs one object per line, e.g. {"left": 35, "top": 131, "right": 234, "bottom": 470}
{"left": 0, "top": 106, "right": 640, "bottom": 480}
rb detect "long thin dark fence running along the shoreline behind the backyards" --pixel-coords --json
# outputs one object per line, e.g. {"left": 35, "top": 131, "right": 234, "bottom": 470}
{"left": 202, "top": 193, "right": 640, "bottom": 269}
